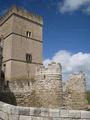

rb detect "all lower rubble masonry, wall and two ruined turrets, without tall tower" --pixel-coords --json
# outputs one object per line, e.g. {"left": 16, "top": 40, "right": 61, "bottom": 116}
{"left": 0, "top": 62, "right": 87, "bottom": 110}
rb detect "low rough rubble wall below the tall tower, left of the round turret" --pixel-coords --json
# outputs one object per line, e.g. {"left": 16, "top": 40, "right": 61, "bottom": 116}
{"left": 0, "top": 80, "right": 34, "bottom": 106}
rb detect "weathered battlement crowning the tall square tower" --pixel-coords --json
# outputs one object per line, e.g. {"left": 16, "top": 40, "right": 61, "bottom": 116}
{"left": 0, "top": 5, "right": 43, "bottom": 25}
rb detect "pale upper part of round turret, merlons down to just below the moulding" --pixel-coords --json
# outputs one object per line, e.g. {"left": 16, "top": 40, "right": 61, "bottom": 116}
{"left": 36, "top": 62, "right": 62, "bottom": 79}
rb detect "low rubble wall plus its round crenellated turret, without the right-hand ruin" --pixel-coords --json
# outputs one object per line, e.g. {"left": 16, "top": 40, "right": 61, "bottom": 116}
{"left": 0, "top": 63, "right": 63, "bottom": 108}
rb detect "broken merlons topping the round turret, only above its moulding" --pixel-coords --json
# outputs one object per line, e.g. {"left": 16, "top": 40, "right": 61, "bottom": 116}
{"left": 36, "top": 62, "right": 62, "bottom": 75}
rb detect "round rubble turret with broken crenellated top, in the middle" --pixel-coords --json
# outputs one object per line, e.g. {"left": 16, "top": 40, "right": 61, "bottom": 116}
{"left": 35, "top": 62, "right": 63, "bottom": 108}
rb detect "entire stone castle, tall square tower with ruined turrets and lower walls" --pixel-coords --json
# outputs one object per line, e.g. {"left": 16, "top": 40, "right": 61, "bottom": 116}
{"left": 0, "top": 6, "right": 87, "bottom": 109}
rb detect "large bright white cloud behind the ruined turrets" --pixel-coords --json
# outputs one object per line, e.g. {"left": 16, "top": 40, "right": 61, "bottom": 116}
{"left": 44, "top": 50, "right": 90, "bottom": 89}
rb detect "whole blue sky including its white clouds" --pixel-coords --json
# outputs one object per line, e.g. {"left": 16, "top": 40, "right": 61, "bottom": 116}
{"left": 0, "top": 0, "right": 90, "bottom": 88}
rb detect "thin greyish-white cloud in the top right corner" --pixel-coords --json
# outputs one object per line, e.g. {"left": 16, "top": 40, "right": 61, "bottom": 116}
{"left": 58, "top": 0, "right": 90, "bottom": 13}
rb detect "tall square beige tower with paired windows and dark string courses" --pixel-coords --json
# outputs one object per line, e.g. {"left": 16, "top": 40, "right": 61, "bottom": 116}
{"left": 0, "top": 6, "right": 43, "bottom": 80}
